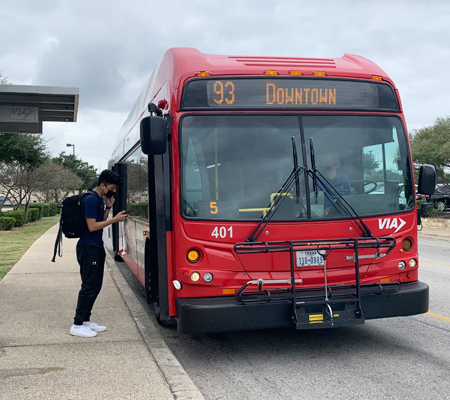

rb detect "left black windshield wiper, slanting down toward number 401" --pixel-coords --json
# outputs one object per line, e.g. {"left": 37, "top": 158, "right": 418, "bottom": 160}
{"left": 245, "top": 137, "right": 304, "bottom": 242}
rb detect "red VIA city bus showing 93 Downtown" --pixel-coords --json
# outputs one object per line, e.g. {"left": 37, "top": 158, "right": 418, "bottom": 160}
{"left": 110, "top": 48, "right": 435, "bottom": 333}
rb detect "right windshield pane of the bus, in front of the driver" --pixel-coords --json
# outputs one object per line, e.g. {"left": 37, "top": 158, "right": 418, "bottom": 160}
{"left": 303, "top": 116, "right": 414, "bottom": 218}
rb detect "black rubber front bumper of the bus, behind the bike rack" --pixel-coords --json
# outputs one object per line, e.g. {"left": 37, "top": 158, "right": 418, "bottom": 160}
{"left": 176, "top": 282, "right": 429, "bottom": 333}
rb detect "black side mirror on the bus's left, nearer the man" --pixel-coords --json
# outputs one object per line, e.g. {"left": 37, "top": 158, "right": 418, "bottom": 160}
{"left": 140, "top": 116, "right": 167, "bottom": 156}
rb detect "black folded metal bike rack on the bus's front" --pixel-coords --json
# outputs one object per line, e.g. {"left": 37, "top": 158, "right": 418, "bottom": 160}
{"left": 234, "top": 237, "right": 398, "bottom": 329}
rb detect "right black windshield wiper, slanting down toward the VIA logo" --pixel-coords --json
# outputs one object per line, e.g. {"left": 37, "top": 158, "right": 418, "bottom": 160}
{"left": 308, "top": 138, "right": 372, "bottom": 237}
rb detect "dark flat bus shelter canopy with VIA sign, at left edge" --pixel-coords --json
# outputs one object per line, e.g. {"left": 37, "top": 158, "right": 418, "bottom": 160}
{"left": 0, "top": 85, "right": 79, "bottom": 133}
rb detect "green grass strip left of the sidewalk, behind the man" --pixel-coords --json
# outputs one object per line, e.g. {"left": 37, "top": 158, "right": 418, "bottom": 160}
{"left": 0, "top": 215, "right": 60, "bottom": 279}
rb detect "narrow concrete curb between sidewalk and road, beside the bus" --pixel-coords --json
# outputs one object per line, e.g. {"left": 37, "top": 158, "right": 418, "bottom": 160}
{"left": 106, "top": 252, "right": 205, "bottom": 400}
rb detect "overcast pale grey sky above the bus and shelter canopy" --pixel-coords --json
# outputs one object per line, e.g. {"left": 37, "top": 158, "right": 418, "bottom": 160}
{"left": 0, "top": 0, "right": 450, "bottom": 169}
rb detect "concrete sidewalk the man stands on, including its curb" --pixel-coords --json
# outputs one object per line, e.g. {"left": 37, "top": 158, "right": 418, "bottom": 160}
{"left": 0, "top": 226, "right": 203, "bottom": 400}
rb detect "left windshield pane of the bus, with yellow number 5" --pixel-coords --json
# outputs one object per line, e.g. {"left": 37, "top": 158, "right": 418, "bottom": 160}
{"left": 181, "top": 115, "right": 304, "bottom": 220}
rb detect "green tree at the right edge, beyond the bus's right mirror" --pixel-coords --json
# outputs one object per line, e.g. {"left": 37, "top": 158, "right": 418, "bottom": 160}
{"left": 411, "top": 117, "right": 450, "bottom": 183}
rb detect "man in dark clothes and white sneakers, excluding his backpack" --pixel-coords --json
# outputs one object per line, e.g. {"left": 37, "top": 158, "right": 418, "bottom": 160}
{"left": 70, "top": 169, "right": 128, "bottom": 337}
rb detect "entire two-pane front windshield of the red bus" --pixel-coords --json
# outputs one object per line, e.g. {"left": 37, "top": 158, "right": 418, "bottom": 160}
{"left": 181, "top": 114, "right": 414, "bottom": 221}
